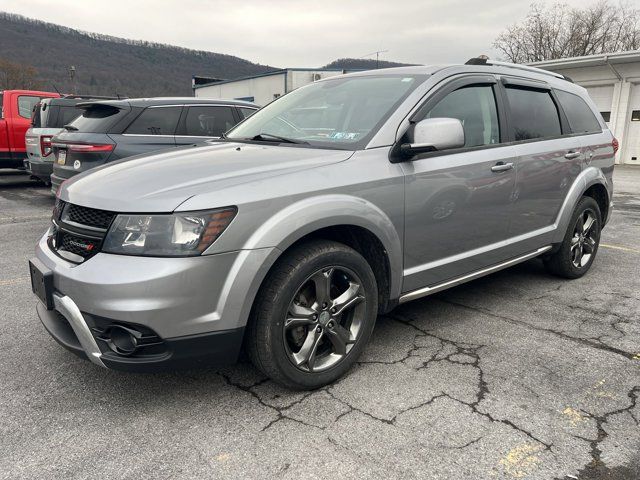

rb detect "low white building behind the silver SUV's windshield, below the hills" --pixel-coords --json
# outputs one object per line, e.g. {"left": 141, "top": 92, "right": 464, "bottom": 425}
{"left": 193, "top": 68, "right": 345, "bottom": 106}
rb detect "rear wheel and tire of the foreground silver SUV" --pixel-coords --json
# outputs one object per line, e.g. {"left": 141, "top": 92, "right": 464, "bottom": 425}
{"left": 544, "top": 197, "right": 602, "bottom": 279}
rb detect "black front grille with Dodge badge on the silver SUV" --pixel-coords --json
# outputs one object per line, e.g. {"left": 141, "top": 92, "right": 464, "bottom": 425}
{"left": 49, "top": 201, "right": 116, "bottom": 263}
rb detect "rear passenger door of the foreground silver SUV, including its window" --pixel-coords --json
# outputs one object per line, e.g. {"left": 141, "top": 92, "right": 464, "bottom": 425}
{"left": 503, "top": 78, "right": 584, "bottom": 240}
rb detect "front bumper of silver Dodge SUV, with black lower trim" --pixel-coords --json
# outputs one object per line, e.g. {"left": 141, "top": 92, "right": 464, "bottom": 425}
{"left": 36, "top": 235, "right": 274, "bottom": 371}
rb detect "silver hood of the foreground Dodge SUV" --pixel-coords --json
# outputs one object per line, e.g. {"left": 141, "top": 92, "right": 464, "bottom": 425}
{"left": 60, "top": 142, "right": 353, "bottom": 213}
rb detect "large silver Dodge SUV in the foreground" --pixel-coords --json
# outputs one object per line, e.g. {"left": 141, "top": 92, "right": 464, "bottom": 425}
{"left": 30, "top": 60, "right": 617, "bottom": 389}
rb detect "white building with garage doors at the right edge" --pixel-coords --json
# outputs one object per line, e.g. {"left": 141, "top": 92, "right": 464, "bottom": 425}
{"left": 530, "top": 51, "right": 640, "bottom": 165}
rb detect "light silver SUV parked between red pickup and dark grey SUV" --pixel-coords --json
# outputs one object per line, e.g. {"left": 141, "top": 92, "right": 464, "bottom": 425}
{"left": 24, "top": 95, "right": 121, "bottom": 185}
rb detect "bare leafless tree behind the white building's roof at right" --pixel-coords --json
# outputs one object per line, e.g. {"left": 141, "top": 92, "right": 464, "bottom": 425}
{"left": 493, "top": 0, "right": 640, "bottom": 63}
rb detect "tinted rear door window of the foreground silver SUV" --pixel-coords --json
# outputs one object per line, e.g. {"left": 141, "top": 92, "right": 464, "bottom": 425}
{"left": 506, "top": 87, "right": 562, "bottom": 140}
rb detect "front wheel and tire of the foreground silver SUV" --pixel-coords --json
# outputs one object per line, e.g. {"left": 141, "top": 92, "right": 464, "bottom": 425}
{"left": 245, "top": 240, "right": 378, "bottom": 390}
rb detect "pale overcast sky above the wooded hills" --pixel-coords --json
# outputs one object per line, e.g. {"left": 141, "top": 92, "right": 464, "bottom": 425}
{"left": 0, "top": 0, "right": 590, "bottom": 67}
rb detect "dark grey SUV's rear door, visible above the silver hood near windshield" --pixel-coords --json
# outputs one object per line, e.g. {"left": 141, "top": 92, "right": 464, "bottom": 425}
{"left": 176, "top": 105, "right": 240, "bottom": 146}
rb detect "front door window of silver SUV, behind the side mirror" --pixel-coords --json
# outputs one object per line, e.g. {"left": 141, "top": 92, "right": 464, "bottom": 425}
{"left": 425, "top": 85, "right": 500, "bottom": 147}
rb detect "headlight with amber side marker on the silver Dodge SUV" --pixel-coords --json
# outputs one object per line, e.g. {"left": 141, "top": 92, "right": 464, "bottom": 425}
{"left": 102, "top": 207, "right": 237, "bottom": 257}
